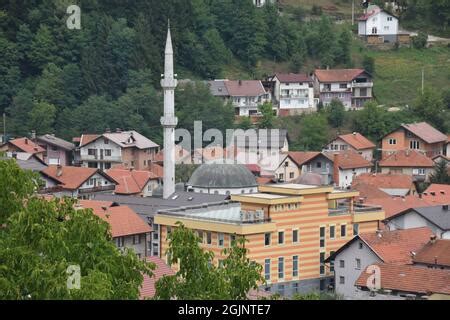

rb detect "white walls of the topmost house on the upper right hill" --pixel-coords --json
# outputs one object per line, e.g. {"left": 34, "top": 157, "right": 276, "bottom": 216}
{"left": 358, "top": 8, "right": 398, "bottom": 42}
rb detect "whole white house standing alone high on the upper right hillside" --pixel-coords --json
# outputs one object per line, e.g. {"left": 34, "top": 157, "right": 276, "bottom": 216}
{"left": 358, "top": 6, "right": 398, "bottom": 43}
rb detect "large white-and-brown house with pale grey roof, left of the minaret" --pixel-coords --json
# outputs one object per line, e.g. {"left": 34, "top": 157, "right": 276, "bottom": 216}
{"left": 75, "top": 129, "right": 159, "bottom": 170}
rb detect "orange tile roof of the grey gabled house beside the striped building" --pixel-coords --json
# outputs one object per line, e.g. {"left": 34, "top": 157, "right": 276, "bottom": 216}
{"left": 359, "top": 227, "right": 433, "bottom": 264}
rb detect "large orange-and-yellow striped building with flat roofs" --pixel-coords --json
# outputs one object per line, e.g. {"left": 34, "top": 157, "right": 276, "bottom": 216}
{"left": 154, "top": 184, "right": 384, "bottom": 296}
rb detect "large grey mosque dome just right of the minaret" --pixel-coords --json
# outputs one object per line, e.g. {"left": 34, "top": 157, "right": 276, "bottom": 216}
{"left": 188, "top": 164, "right": 258, "bottom": 188}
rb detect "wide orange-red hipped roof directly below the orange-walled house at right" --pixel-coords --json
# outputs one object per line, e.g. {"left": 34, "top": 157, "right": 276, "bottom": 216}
{"left": 379, "top": 150, "right": 434, "bottom": 168}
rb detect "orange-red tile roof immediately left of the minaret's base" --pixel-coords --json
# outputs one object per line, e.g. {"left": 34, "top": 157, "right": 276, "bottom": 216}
{"left": 105, "top": 168, "right": 158, "bottom": 194}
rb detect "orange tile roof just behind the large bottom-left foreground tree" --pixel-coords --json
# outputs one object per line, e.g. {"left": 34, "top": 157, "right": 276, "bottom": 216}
{"left": 79, "top": 200, "right": 152, "bottom": 238}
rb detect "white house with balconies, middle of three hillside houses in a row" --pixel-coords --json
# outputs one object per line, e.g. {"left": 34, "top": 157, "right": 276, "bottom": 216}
{"left": 272, "top": 73, "right": 318, "bottom": 115}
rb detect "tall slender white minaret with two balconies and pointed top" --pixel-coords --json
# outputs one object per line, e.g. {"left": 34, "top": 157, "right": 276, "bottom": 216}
{"left": 161, "top": 24, "right": 178, "bottom": 199}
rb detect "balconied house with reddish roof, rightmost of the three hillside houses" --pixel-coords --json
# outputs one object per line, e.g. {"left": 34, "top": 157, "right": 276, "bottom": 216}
{"left": 313, "top": 69, "right": 373, "bottom": 110}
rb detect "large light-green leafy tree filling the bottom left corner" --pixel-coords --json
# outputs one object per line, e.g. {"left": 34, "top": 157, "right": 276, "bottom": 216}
{"left": 0, "top": 160, "right": 154, "bottom": 300}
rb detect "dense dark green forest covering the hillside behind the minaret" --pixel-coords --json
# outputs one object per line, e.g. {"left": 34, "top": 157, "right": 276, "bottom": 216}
{"left": 0, "top": 0, "right": 450, "bottom": 149}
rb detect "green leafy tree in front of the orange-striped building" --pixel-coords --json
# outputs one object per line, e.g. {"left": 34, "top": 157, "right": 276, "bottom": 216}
{"left": 155, "top": 223, "right": 264, "bottom": 300}
